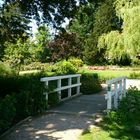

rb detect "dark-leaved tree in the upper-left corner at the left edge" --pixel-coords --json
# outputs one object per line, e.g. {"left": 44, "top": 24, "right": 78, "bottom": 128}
{"left": 0, "top": 3, "right": 30, "bottom": 59}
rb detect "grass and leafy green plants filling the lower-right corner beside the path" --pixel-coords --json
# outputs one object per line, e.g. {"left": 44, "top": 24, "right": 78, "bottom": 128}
{"left": 79, "top": 87, "right": 140, "bottom": 140}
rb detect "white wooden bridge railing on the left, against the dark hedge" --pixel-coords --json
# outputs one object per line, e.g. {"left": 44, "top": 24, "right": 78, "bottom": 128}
{"left": 40, "top": 74, "right": 81, "bottom": 102}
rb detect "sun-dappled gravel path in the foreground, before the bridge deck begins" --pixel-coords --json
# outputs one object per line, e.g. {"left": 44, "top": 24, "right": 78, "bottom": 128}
{"left": 2, "top": 113, "right": 93, "bottom": 140}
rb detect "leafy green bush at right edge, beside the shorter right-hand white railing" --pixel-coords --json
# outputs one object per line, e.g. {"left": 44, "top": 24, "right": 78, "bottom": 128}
{"left": 118, "top": 87, "right": 140, "bottom": 123}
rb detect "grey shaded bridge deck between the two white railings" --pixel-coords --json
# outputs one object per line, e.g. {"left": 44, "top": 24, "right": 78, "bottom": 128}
{"left": 50, "top": 92, "right": 106, "bottom": 116}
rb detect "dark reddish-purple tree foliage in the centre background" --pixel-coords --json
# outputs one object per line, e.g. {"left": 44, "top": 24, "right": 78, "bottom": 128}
{"left": 48, "top": 32, "right": 82, "bottom": 62}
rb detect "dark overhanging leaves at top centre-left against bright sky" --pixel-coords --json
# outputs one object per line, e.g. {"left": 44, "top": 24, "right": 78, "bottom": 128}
{"left": 5, "top": 0, "right": 87, "bottom": 28}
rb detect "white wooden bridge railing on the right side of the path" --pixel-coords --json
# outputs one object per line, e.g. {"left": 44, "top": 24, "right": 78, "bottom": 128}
{"left": 105, "top": 77, "right": 126, "bottom": 110}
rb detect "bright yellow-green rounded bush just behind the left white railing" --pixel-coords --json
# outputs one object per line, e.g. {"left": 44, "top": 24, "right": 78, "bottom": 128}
{"left": 53, "top": 60, "right": 78, "bottom": 75}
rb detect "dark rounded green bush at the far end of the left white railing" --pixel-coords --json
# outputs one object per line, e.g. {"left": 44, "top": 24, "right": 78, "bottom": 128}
{"left": 81, "top": 73, "right": 102, "bottom": 94}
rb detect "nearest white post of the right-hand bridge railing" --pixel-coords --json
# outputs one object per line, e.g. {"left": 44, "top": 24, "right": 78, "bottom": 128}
{"left": 107, "top": 84, "right": 112, "bottom": 110}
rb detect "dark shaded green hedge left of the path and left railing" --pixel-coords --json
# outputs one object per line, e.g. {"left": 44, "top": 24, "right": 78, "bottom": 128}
{"left": 0, "top": 74, "right": 48, "bottom": 133}
